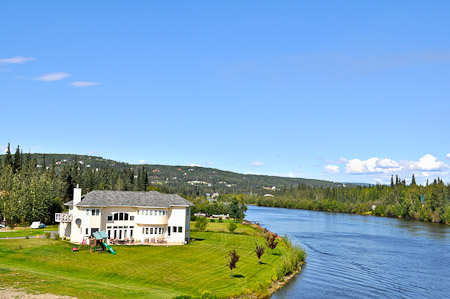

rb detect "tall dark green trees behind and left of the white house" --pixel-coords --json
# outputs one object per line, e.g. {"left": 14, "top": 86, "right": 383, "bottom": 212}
{"left": 0, "top": 144, "right": 153, "bottom": 227}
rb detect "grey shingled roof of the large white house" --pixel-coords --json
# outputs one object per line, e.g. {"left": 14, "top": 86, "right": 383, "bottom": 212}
{"left": 64, "top": 190, "right": 193, "bottom": 208}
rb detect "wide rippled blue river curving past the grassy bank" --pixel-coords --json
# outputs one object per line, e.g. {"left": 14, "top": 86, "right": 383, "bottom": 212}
{"left": 246, "top": 206, "right": 450, "bottom": 299}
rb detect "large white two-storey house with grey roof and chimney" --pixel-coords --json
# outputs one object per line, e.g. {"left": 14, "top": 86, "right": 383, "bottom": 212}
{"left": 55, "top": 186, "right": 193, "bottom": 244}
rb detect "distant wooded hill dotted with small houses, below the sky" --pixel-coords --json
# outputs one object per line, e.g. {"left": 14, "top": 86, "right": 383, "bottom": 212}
{"left": 0, "top": 153, "right": 342, "bottom": 195}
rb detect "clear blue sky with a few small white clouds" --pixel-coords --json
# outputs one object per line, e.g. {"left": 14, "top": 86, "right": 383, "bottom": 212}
{"left": 0, "top": 1, "right": 450, "bottom": 183}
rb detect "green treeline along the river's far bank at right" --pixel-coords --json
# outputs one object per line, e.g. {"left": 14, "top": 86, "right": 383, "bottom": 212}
{"left": 245, "top": 176, "right": 450, "bottom": 223}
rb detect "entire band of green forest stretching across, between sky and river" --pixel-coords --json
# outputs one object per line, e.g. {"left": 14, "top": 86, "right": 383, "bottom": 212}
{"left": 0, "top": 144, "right": 450, "bottom": 226}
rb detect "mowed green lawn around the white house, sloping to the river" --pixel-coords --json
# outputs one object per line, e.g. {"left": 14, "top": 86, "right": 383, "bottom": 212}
{"left": 0, "top": 223, "right": 286, "bottom": 298}
